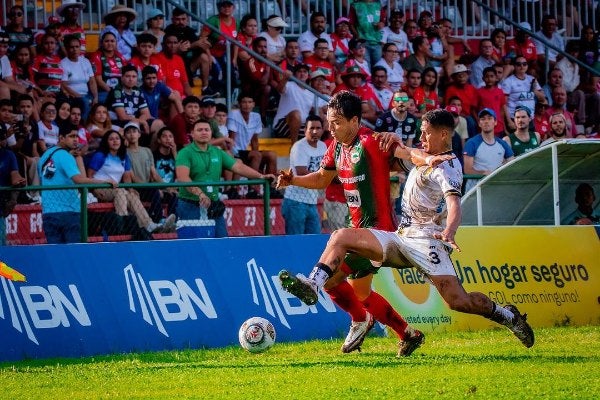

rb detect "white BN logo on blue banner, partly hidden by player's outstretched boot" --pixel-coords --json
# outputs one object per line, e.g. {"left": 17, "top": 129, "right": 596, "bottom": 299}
{"left": 246, "top": 258, "right": 337, "bottom": 329}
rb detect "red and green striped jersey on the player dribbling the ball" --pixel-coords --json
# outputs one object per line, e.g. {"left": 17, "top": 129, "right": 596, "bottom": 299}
{"left": 321, "top": 127, "right": 398, "bottom": 231}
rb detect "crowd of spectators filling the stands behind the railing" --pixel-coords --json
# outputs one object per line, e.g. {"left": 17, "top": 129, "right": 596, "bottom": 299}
{"left": 0, "top": 0, "right": 600, "bottom": 241}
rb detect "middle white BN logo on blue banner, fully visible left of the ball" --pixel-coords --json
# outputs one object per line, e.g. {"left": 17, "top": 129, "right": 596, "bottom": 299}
{"left": 123, "top": 264, "right": 217, "bottom": 337}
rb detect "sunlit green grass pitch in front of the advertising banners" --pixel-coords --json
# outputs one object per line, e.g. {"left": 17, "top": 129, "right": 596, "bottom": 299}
{"left": 0, "top": 326, "right": 600, "bottom": 400}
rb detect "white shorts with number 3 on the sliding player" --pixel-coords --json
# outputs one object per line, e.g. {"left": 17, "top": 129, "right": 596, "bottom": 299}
{"left": 369, "top": 229, "right": 456, "bottom": 276}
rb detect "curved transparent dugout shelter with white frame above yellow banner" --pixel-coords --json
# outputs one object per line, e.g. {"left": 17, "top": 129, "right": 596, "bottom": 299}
{"left": 462, "top": 139, "right": 600, "bottom": 226}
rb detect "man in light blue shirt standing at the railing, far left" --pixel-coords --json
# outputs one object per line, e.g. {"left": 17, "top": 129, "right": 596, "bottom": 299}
{"left": 38, "top": 125, "right": 117, "bottom": 244}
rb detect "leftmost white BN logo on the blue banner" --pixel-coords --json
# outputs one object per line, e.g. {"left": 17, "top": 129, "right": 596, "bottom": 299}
{"left": 0, "top": 278, "right": 92, "bottom": 345}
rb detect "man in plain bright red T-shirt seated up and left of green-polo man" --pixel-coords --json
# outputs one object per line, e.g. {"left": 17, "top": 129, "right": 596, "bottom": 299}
{"left": 154, "top": 32, "right": 192, "bottom": 97}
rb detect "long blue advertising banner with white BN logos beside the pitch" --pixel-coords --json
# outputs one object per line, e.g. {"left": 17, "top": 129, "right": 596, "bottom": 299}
{"left": 0, "top": 235, "right": 381, "bottom": 361}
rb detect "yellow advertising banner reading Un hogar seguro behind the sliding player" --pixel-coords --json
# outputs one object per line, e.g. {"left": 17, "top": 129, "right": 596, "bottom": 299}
{"left": 374, "top": 226, "right": 600, "bottom": 331}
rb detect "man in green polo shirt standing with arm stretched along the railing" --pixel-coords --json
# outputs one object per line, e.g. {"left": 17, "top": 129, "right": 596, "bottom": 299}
{"left": 175, "top": 119, "right": 275, "bottom": 237}
